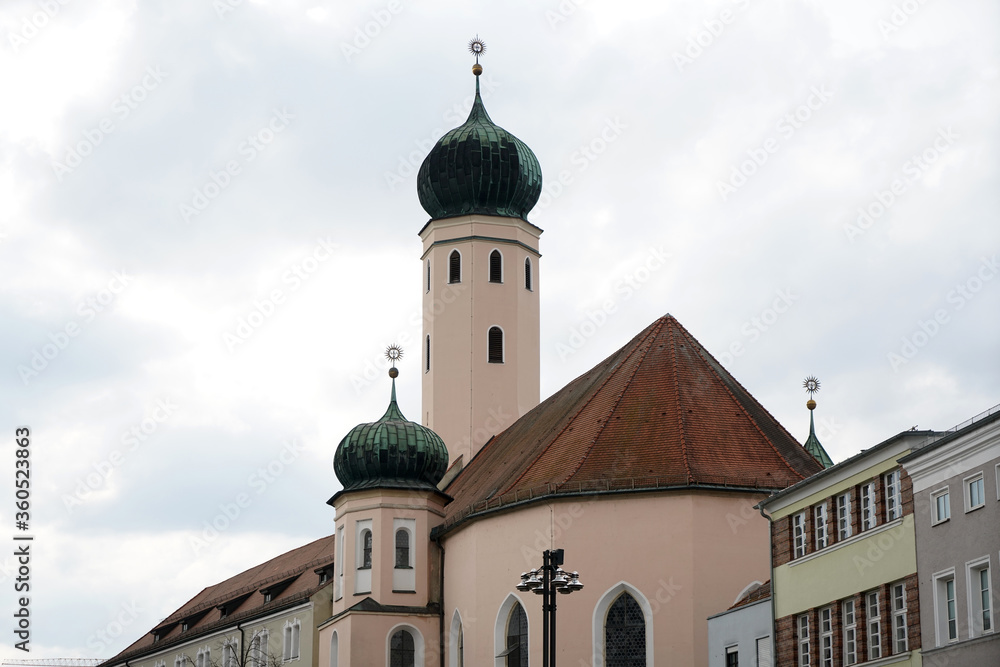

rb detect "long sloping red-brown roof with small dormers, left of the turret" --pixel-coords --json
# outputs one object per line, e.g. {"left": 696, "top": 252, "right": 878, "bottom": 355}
{"left": 105, "top": 535, "right": 334, "bottom": 665}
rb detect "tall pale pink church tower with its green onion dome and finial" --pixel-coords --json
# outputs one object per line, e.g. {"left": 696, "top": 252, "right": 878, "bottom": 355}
{"left": 417, "top": 38, "right": 542, "bottom": 465}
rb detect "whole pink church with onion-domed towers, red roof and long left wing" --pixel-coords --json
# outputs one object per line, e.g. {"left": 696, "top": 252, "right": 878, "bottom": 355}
{"left": 104, "top": 51, "right": 829, "bottom": 667}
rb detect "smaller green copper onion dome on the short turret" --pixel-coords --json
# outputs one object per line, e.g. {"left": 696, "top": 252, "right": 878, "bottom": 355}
{"left": 333, "top": 380, "right": 448, "bottom": 491}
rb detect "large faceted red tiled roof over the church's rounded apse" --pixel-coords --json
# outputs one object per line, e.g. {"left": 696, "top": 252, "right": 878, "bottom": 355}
{"left": 443, "top": 315, "right": 823, "bottom": 529}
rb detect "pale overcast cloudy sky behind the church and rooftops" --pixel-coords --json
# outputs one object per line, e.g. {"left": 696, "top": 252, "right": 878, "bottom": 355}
{"left": 0, "top": 0, "right": 1000, "bottom": 658}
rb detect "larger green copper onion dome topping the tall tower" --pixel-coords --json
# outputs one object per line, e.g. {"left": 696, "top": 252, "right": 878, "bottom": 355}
{"left": 417, "top": 75, "right": 542, "bottom": 220}
